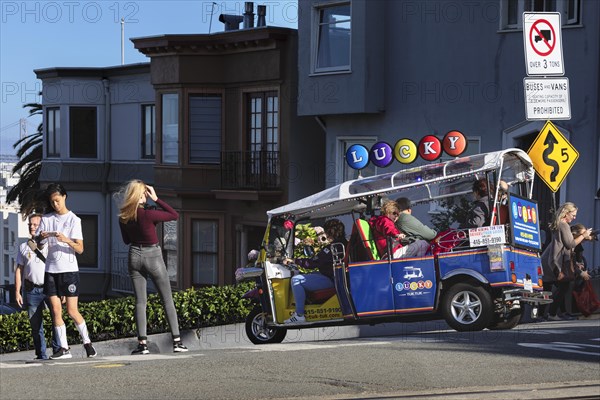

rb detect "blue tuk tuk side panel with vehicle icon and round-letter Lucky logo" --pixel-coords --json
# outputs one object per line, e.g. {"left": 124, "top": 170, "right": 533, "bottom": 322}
{"left": 391, "top": 257, "right": 438, "bottom": 313}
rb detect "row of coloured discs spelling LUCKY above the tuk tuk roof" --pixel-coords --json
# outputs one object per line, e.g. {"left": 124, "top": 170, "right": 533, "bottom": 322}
{"left": 346, "top": 131, "right": 467, "bottom": 169}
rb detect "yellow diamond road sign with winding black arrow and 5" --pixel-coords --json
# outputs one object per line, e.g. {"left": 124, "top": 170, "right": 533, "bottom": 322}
{"left": 527, "top": 121, "right": 579, "bottom": 192}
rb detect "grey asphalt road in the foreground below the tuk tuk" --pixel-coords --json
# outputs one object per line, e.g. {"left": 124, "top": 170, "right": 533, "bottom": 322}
{"left": 0, "top": 319, "right": 600, "bottom": 400}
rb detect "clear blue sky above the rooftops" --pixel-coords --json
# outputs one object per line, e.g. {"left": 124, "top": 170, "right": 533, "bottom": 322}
{"left": 0, "top": 0, "right": 298, "bottom": 158}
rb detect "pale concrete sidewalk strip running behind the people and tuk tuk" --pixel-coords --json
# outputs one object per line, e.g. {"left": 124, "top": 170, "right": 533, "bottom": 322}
{"left": 0, "top": 312, "right": 600, "bottom": 362}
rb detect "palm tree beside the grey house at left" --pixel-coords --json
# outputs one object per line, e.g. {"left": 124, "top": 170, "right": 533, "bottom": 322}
{"left": 6, "top": 97, "right": 43, "bottom": 216}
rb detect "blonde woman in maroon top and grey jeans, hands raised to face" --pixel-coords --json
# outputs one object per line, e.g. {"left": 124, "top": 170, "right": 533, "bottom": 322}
{"left": 119, "top": 179, "right": 188, "bottom": 354}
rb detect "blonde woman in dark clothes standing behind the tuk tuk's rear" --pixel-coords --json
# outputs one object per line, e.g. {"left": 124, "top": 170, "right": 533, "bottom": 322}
{"left": 542, "top": 202, "right": 592, "bottom": 321}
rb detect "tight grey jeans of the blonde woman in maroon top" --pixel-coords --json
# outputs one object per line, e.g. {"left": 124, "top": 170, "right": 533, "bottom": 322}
{"left": 128, "top": 246, "right": 179, "bottom": 340}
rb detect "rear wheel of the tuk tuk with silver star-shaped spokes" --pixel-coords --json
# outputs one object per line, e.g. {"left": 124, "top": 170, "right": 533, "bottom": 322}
{"left": 442, "top": 283, "right": 493, "bottom": 332}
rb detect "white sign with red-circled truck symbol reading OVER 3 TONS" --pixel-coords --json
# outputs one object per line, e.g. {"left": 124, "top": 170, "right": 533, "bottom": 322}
{"left": 523, "top": 12, "right": 565, "bottom": 76}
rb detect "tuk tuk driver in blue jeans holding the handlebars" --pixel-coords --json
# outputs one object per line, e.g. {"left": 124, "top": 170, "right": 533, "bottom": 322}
{"left": 283, "top": 218, "right": 347, "bottom": 324}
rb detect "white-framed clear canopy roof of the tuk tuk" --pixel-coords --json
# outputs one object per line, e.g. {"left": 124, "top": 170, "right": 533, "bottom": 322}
{"left": 267, "top": 148, "right": 534, "bottom": 220}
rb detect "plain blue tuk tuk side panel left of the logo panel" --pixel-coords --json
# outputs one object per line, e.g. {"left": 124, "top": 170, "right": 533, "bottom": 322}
{"left": 348, "top": 261, "right": 394, "bottom": 317}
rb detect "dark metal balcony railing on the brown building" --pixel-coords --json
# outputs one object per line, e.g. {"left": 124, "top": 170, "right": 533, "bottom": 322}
{"left": 221, "top": 151, "right": 281, "bottom": 190}
